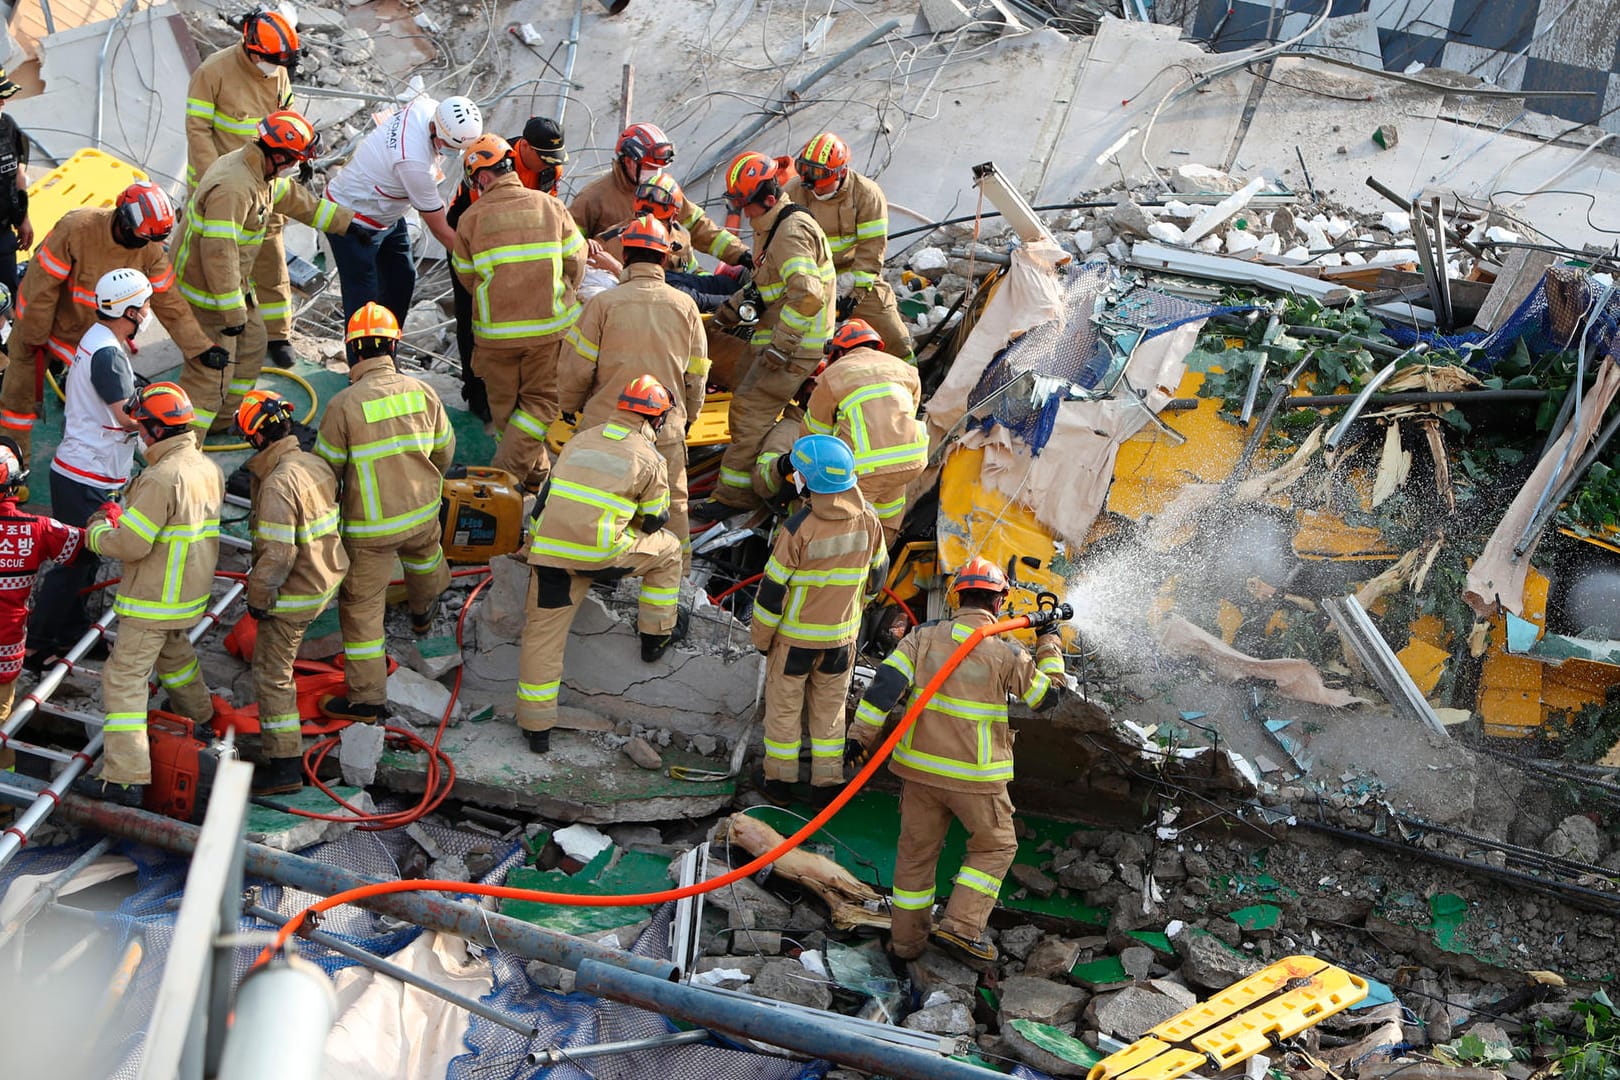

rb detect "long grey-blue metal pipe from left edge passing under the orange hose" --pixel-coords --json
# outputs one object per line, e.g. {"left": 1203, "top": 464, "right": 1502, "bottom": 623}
{"left": 13, "top": 776, "right": 676, "bottom": 978}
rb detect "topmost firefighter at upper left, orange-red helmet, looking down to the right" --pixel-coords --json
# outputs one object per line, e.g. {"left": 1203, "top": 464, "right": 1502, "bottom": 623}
{"left": 186, "top": 11, "right": 298, "bottom": 368}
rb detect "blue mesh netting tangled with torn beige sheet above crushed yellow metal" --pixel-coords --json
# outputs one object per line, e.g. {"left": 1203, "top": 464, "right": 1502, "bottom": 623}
{"left": 967, "top": 261, "right": 1251, "bottom": 453}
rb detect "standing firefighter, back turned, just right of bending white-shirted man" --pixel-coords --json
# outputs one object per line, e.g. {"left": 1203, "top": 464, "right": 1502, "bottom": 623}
{"left": 450, "top": 134, "right": 585, "bottom": 491}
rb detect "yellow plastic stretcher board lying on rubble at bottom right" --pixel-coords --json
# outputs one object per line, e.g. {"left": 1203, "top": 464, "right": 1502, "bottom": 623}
{"left": 1087, "top": 957, "right": 1367, "bottom": 1080}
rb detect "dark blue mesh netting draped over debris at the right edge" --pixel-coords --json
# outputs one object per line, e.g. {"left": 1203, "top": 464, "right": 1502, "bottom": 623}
{"left": 1383, "top": 267, "right": 1620, "bottom": 371}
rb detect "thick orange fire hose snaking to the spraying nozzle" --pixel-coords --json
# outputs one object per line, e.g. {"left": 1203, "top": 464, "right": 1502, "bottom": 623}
{"left": 254, "top": 615, "right": 1034, "bottom": 967}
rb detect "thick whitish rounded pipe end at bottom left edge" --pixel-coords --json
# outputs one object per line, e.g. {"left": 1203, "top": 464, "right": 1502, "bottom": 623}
{"left": 219, "top": 957, "right": 337, "bottom": 1080}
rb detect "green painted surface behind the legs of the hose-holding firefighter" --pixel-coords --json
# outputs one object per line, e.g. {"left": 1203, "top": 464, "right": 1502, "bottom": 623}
{"left": 748, "top": 790, "right": 1108, "bottom": 926}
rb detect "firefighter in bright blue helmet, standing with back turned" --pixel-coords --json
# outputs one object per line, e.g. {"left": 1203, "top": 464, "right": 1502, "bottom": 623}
{"left": 752, "top": 436, "right": 889, "bottom": 803}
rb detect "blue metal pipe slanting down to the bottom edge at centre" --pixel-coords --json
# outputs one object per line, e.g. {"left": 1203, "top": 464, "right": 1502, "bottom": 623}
{"left": 573, "top": 960, "right": 985, "bottom": 1080}
